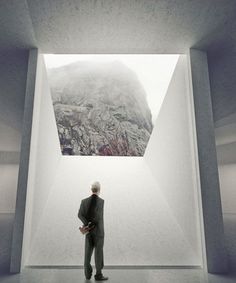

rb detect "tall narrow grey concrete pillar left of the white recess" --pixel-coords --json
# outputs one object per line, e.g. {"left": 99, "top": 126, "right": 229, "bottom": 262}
{"left": 11, "top": 49, "right": 38, "bottom": 272}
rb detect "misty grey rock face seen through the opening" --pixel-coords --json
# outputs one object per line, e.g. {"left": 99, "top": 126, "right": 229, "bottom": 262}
{"left": 49, "top": 61, "right": 153, "bottom": 156}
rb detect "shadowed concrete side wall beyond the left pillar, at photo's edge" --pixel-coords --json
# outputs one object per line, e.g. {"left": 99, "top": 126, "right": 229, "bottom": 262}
{"left": 0, "top": 50, "right": 28, "bottom": 272}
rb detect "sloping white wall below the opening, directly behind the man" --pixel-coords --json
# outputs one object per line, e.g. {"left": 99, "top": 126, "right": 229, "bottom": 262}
{"left": 28, "top": 157, "right": 200, "bottom": 265}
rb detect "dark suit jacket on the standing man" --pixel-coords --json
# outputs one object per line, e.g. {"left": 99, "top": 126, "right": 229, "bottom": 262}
{"left": 78, "top": 195, "right": 104, "bottom": 237}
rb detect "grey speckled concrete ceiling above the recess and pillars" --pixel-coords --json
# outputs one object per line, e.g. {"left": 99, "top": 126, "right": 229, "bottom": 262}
{"left": 0, "top": 0, "right": 236, "bottom": 53}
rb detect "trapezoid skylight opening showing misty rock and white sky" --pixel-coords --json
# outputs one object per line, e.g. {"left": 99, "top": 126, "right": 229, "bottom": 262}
{"left": 45, "top": 55, "right": 178, "bottom": 156}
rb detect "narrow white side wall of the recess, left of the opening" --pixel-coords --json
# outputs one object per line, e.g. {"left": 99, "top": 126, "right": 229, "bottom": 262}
{"left": 23, "top": 55, "right": 61, "bottom": 266}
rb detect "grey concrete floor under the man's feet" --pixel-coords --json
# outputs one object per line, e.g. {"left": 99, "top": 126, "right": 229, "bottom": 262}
{"left": 0, "top": 268, "right": 236, "bottom": 283}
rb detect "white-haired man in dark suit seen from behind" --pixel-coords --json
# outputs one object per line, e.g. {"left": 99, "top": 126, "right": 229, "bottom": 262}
{"left": 78, "top": 182, "right": 108, "bottom": 281}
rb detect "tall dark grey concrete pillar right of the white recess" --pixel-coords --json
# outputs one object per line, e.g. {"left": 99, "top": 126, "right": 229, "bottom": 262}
{"left": 190, "top": 49, "right": 228, "bottom": 272}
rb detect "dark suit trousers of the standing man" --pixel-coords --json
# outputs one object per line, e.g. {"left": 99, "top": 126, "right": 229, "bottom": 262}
{"left": 84, "top": 232, "right": 104, "bottom": 278}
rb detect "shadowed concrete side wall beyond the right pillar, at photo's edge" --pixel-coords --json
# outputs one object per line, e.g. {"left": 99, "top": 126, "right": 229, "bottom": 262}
{"left": 208, "top": 41, "right": 236, "bottom": 271}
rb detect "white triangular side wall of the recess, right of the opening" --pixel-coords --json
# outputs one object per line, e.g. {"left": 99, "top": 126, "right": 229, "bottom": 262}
{"left": 145, "top": 55, "right": 201, "bottom": 258}
